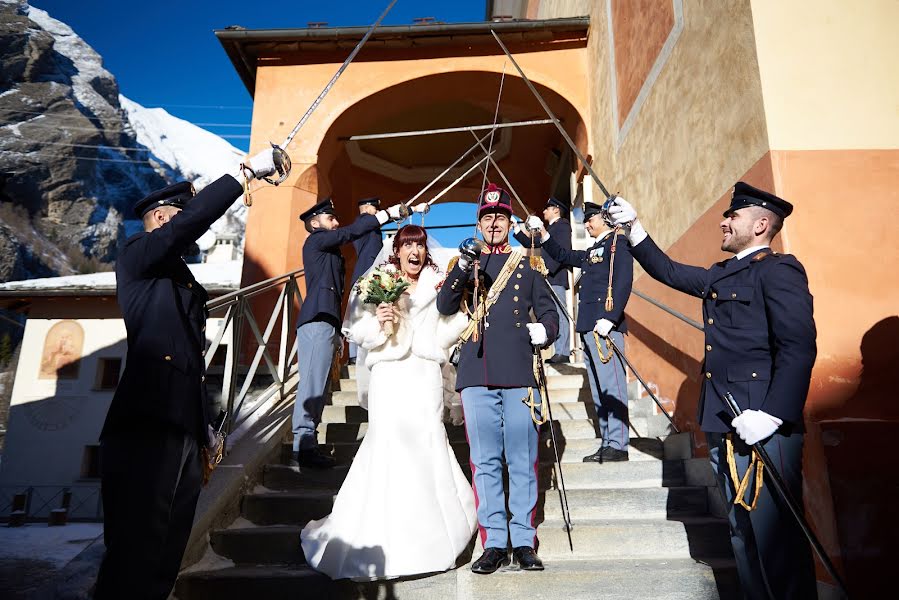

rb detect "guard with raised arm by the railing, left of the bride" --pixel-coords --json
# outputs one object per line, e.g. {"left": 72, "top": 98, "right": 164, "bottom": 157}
{"left": 292, "top": 198, "right": 407, "bottom": 468}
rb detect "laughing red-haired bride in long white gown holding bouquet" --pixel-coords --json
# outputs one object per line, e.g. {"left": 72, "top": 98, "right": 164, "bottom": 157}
{"left": 301, "top": 225, "right": 477, "bottom": 580}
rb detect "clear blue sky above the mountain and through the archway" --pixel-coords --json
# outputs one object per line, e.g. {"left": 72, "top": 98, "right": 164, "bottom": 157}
{"left": 30, "top": 0, "right": 524, "bottom": 246}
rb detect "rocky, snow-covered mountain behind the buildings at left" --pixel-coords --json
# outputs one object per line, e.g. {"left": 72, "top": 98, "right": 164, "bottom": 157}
{"left": 0, "top": 0, "right": 246, "bottom": 281}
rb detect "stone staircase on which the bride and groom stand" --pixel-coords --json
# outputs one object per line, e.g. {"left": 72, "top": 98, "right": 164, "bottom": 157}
{"left": 175, "top": 365, "right": 740, "bottom": 600}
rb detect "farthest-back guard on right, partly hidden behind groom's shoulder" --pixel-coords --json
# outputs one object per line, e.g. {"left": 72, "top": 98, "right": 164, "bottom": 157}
{"left": 514, "top": 197, "right": 571, "bottom": 364}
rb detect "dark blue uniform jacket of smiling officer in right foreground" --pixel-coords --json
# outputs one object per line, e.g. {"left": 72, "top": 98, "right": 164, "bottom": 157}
{"left": 631, "top": 238, "right": 817, "bottom": 433}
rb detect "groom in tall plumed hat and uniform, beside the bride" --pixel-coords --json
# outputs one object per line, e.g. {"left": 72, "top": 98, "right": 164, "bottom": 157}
{"left": 437, "top": 184, "right": 559, "bottom": 574}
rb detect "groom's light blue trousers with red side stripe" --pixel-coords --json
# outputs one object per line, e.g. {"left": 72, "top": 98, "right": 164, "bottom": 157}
{"left": 462, "top": 386, "right": 540, "bottom": 549}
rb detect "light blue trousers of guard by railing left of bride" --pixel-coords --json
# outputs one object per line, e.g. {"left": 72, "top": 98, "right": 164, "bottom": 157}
{"left": 291, "top": 321, "right": 337, "bottom": 451}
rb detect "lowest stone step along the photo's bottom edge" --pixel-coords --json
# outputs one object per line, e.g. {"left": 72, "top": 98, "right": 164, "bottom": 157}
{"left": 175, "top": 559, "right": 740, "bottom": 600}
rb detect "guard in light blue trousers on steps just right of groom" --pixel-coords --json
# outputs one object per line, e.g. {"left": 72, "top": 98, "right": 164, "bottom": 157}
{"left": 541, "top": 202, "right": 634, "bottom": 463}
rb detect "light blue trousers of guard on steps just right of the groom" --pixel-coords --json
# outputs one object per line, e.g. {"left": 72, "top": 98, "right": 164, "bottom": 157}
{"left": 581, "top": 331, "right": 630, "bottom": 451}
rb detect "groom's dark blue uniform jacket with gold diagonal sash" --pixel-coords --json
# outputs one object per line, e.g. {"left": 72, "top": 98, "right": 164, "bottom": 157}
{"left": 437, "top": 247, "right": 559, "bottom": 391}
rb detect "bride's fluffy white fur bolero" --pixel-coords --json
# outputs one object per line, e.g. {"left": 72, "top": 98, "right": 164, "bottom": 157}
{"left": 342, "top": 267, "right": 468, "bottom": 369}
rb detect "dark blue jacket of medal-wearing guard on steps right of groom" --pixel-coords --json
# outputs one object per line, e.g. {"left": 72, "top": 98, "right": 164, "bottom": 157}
{"left": 543, "top": 233, "right": 634, "bottom": 333}
